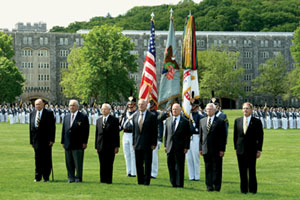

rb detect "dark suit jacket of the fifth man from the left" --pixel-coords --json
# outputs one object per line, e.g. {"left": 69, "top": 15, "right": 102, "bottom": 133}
{"left": 165, "top": 116, "right": 191, "bottom": 153}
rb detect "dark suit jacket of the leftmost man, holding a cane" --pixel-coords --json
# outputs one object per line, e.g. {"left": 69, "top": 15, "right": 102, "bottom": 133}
{"left": 29, "top": 108, "right": 55, "bottom": 148}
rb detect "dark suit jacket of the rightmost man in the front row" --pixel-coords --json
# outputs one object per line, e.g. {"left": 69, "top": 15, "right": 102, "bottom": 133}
{"left": 233, "top": 117, "right": 264, "bottom": 154}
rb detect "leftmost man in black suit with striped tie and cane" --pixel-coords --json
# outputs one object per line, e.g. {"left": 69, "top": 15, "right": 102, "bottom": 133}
{"left": 29, "top": 99, "right": 55, "bottom": 182}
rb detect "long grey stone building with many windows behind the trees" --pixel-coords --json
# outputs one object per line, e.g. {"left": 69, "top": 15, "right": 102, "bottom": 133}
{"left": 4, "top": 23, "right": 300, "bottom": 107}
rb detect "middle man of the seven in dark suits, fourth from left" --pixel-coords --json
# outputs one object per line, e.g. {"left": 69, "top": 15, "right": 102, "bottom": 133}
{"left": 132, "top": 99, "right": 158, "bottom": 185}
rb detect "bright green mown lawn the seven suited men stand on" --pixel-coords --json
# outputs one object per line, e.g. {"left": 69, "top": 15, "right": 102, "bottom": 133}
{"left": 0, "top": 110, "right": 300, "bottom": 200}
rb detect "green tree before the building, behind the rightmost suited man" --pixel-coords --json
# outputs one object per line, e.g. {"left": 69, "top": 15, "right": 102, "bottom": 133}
{"left": 252, "top": 54, "right": 289, "bottom": 104}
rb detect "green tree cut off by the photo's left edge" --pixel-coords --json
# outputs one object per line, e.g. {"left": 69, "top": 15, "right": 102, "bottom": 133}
{"left": 0, "top": 32, "right": 25, "bottom": 103}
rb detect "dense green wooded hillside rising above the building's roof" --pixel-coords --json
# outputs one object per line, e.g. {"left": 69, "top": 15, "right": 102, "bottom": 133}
{"left": 51, "top": 0, "right": 300, "bottom": 32}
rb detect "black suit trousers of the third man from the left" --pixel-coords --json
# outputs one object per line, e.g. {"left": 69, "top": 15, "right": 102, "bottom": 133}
{"left": 98, "top": 148, "right": 115, "bottom": 183}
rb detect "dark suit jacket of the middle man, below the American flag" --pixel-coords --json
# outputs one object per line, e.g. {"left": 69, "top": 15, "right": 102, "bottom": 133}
{"left": 132, "top": 111, "right": 158, "bottom": 150}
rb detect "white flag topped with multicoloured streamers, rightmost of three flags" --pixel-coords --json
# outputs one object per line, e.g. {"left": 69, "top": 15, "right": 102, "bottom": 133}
{"left": 182, "top": 15, "right": 199, "bottom": 119}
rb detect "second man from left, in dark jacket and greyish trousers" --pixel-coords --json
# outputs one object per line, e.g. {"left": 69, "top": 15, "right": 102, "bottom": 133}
{"left": 61, "top": 100, "right": 90, "bottom": 183}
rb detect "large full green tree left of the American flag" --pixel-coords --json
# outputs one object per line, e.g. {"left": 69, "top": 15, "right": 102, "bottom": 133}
{"left": 61, "top": 25, "right": 137, "bottom": 102}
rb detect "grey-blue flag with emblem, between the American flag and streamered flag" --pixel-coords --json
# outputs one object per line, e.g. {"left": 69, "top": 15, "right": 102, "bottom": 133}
{"left": 158, "top": 10, "right": 180, "bottom": 109}
